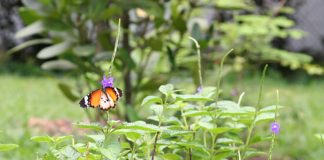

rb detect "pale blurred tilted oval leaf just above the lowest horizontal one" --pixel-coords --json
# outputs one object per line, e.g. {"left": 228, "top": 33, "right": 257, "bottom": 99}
{"left": 37, "top": 42, "right": 71, "bottom": 59}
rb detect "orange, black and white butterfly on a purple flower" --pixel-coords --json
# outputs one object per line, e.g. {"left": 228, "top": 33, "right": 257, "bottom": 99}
{"left": 79, "top": 87, "right": 122, "bottom": 110}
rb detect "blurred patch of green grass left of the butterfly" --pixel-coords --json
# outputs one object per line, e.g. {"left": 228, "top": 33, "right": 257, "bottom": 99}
{"left": 0, "top": 74, "right": 86, "bottom": 159}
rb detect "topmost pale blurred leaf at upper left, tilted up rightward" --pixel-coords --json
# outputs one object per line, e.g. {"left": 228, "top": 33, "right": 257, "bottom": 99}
{"left": 15, "top": 21, "right": 45, "bottom": 39}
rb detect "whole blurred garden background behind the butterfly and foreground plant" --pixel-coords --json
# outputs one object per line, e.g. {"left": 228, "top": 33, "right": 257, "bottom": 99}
{"left": 0, "top": 0, "right": 324, "bottom": 160}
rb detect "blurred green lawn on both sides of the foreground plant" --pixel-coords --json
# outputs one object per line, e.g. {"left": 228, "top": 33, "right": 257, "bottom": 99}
{"left": 0, "top": 73, "right": 324, "bottom": 159}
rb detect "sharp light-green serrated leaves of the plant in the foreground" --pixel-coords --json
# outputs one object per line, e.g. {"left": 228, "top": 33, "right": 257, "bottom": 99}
{"left": 32, "top": 84, "right": 281, "bottom": 159}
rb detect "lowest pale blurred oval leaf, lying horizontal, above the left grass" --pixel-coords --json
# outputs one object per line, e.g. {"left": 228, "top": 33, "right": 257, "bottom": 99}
{"left": 41, "top": 59, "right": 76, "bottom": 70}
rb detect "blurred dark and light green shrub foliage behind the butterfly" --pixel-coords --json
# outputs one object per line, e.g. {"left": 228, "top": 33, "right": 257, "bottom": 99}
{"left": 9, "top": 0, "right": 323, "bottom": 119}
